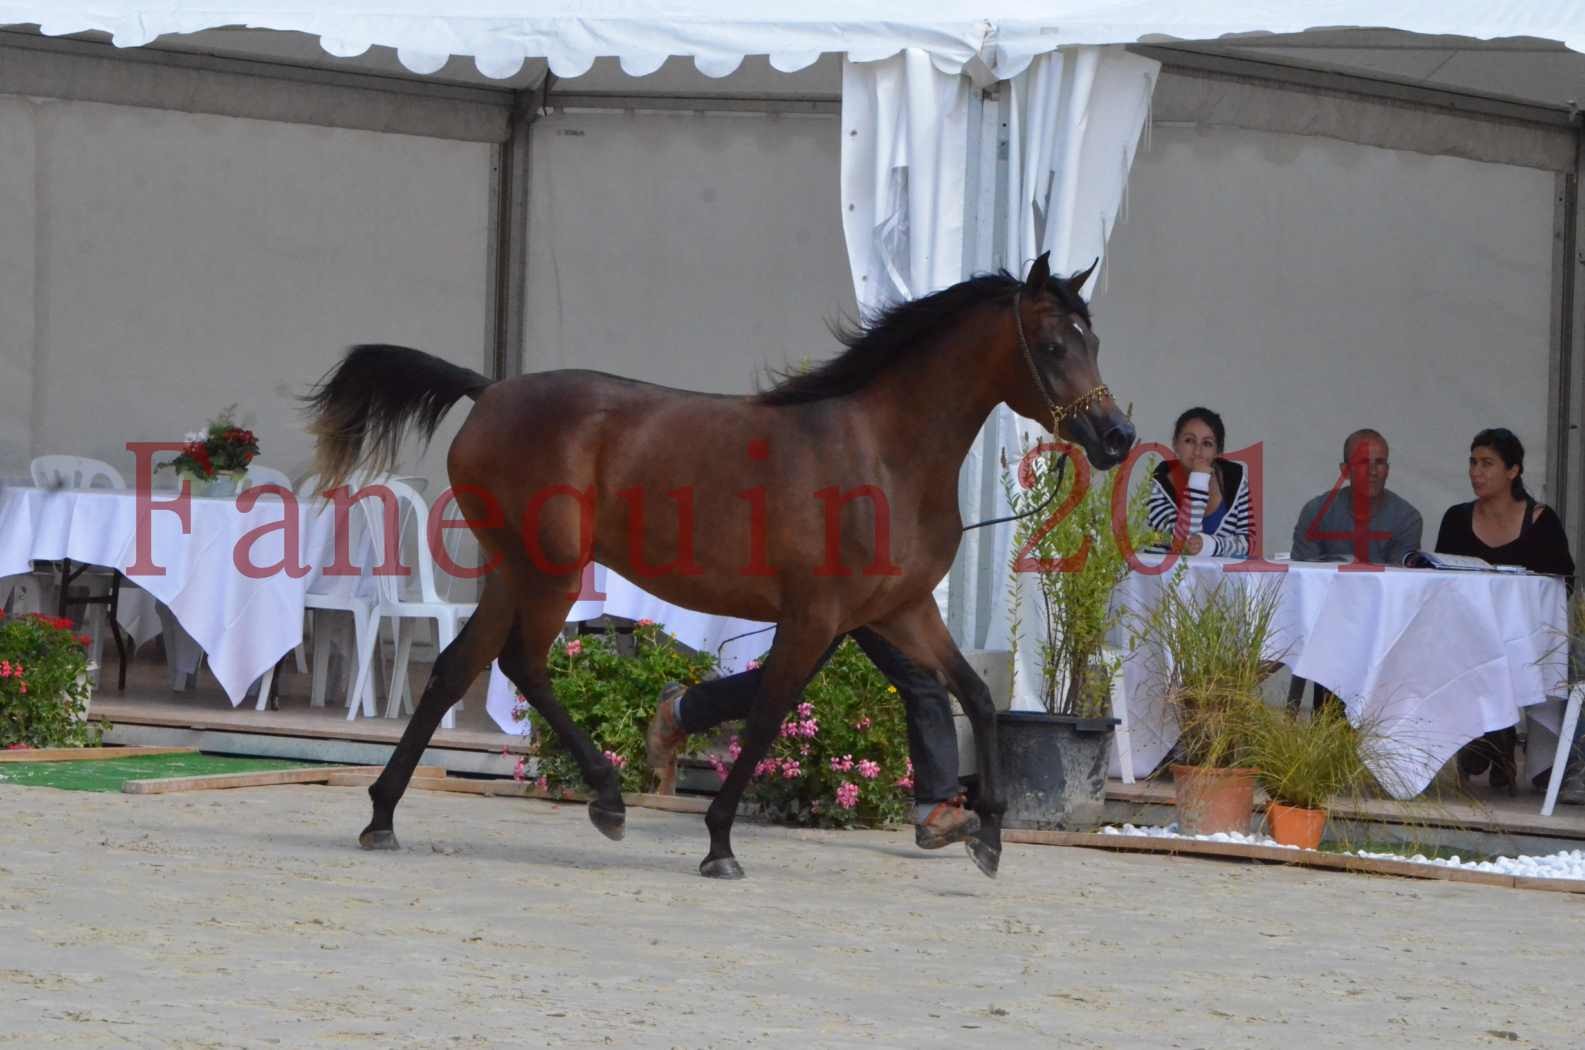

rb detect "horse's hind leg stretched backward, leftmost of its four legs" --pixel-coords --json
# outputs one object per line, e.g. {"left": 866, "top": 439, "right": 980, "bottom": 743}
{"left": 358, "top": 574, "right": 512, "bottom": 850}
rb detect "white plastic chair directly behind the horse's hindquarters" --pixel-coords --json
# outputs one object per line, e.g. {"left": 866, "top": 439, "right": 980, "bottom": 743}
{"left": 361, "top": 477, "right": 477, "bottom": 730}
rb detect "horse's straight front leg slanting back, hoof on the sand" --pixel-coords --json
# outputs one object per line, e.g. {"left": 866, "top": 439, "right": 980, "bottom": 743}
{"left": 699, "top": 623, "right": 835, "bottom": 879}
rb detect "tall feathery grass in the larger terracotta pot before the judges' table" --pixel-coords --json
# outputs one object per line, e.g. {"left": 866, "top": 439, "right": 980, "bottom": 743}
{"left": 1140, "top": 565, "right": 1279, "bottom": 834}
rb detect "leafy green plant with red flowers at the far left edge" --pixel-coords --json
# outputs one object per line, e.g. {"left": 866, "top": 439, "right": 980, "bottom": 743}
{"left": 0, "top": 612, "right": 105, "bottom": 749}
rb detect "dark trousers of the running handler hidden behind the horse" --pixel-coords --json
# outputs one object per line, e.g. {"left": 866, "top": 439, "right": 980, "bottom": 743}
{"left": 682, "top": 628, "right": 959, "bottom": 803}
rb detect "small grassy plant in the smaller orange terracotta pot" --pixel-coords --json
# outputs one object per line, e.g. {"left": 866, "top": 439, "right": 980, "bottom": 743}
{"left": 1249, "top": 704, "right": 1371, "bottom": 850}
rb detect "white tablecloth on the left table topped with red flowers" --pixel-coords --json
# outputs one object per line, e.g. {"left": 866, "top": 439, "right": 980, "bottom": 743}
{"left": 0, "top": 485, "right": 334, "bottom": 704}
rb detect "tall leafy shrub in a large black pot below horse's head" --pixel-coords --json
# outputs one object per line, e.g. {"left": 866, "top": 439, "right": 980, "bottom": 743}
{"left": 997, "top": 438, "right": 1160, "bottom": 830}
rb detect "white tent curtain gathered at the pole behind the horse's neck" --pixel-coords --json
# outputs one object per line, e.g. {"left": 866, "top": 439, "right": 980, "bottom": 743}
{"left": 842, "top": 48, "right": 1160, "bottom": 706}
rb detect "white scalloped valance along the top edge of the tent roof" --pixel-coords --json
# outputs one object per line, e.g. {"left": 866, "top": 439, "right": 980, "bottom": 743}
{"left": 0, "top": 0, "right": 1585, "bottom": 79}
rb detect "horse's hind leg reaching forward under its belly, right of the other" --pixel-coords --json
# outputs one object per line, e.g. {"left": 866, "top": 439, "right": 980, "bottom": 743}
{"left": 501, "top": 579, "right": 628, "bottom": 839}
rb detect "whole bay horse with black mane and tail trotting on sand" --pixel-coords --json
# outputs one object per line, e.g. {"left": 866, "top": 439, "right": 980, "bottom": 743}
{"left": 303, "top": 252, "right": 1135, "bottom": 879}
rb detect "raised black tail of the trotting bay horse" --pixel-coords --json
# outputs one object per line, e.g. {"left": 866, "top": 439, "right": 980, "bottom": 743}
{"left": 301, "top": 346, "right": 493, "bottom": 492}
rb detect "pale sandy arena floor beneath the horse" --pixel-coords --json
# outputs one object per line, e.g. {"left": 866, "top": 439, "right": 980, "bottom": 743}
{"left": 0, "top": 785, "right": 1585, "bottom": 1050}
